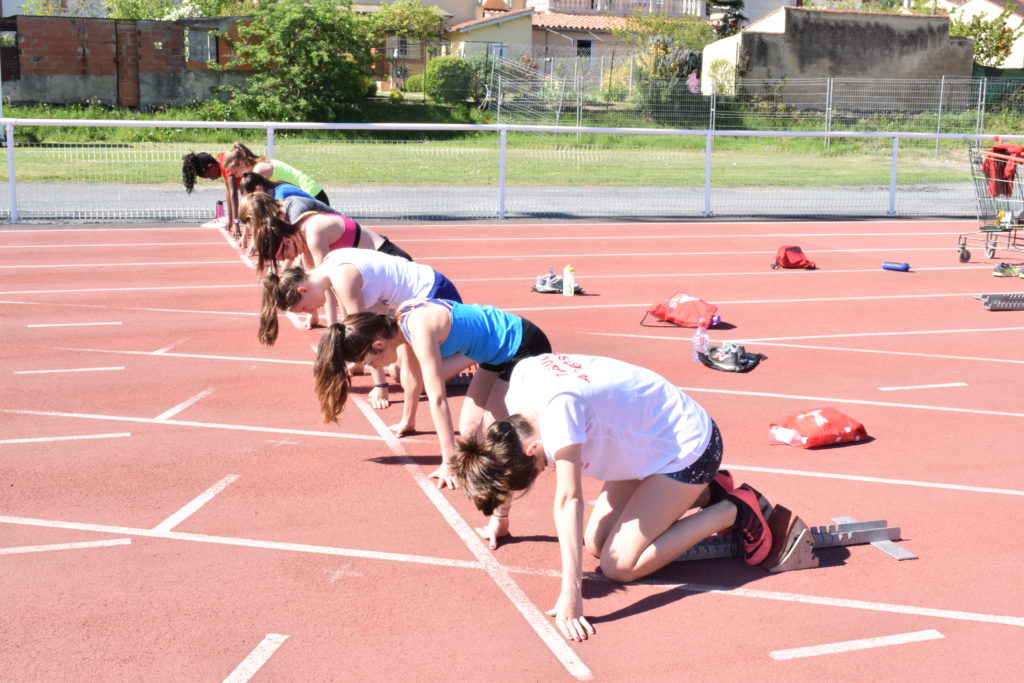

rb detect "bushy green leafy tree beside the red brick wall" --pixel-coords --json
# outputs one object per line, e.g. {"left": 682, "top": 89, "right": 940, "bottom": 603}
{"left": 218, "top": 0, "right": 373, "bottom": 121}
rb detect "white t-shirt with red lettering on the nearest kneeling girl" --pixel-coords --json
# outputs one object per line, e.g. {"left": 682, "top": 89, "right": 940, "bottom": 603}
{"left": 505, "top": 353, "right": 712, "bottom": 481}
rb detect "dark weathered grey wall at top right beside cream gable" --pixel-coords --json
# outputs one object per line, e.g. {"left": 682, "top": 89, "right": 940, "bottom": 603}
{"left": 739, "top": 7, "right": 974, "bottom": 79}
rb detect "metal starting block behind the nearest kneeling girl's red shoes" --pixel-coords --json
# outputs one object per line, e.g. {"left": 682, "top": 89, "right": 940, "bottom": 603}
{"left": 676, "top": 505, "right": 918, "bottom": 573}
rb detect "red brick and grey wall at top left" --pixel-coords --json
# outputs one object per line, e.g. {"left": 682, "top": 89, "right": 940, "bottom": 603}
{"left": 3, "top": 15, "right": 246, "bottom": 110}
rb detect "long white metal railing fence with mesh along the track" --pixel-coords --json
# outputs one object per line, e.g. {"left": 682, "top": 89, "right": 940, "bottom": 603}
{"left": 0, "top": 119, "right": 1012, "bottom": 222}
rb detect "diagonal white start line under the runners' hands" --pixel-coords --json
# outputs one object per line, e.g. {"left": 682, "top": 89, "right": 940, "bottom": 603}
{"left": 354, "top": 398, "right": 594, "bottom": 681}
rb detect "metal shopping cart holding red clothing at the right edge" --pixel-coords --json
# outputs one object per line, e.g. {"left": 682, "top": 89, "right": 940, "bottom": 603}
{"left": 956, "top": 142, "right": 1024, "bottom": 263}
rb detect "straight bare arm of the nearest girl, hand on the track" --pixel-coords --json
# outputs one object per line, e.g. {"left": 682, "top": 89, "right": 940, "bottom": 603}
{"left": 548, "top": 444, "right": 594, "bottom": 641}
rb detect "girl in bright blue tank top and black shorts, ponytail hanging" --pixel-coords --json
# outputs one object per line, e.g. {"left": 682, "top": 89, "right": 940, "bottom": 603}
{"left": 316, "top": 298, "right": 551, "bottom": 488}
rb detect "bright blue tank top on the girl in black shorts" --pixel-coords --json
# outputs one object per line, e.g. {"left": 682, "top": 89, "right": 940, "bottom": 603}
{"left": 397, "top": 299, "right": 522, "bottom": 366}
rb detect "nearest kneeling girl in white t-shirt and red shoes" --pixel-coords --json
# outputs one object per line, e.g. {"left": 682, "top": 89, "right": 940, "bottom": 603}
{"left": 451, "top": 353, "right": 770, "bottom": 641}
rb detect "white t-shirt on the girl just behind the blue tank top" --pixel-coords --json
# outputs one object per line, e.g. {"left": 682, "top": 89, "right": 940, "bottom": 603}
{"left": 321, "top": 247, "right": 434, "bottom": 313}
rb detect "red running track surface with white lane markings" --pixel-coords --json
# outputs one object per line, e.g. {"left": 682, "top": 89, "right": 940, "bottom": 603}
{"left": 0, "top": 222, "right": 1024, "bottom": 681}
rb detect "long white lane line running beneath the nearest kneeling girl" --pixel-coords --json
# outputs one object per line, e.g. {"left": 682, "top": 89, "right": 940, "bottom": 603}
{"left": 0, "top": 511, "right": 1024, "bottom": 628}
